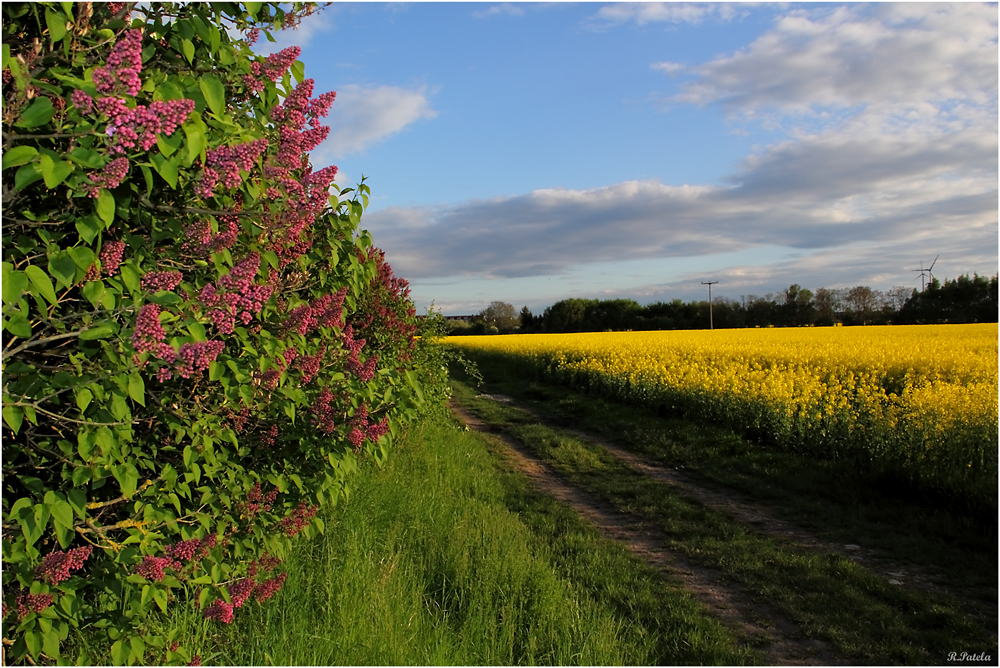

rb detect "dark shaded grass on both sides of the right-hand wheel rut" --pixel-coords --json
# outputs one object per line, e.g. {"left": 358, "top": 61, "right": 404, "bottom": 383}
{"left": 456, "top": 360, "right": 996, "bottom": 664}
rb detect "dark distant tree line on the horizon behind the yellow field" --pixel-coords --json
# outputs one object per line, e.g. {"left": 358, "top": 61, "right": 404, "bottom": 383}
{"left": 451, "top": 274, "right": 997, "bottom": 334}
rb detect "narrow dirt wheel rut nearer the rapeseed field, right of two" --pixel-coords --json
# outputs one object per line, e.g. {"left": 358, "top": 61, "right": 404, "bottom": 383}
{"left": 470, "top": 394, "right": 998, "bottom": 641}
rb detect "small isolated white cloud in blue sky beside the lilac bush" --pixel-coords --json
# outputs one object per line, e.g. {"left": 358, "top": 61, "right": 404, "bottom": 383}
{"left": 316, "top": 84, "right": 437, "bottom": 159}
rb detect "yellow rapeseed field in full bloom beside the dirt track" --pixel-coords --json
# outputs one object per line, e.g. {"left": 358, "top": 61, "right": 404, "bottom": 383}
{"left": 447, "top": 323, "right": 997, "bottom": 502}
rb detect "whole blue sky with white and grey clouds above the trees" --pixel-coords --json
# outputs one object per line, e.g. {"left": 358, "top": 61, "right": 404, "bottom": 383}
{"left": 255, "top": 2, "right": 998, "bottom": 315}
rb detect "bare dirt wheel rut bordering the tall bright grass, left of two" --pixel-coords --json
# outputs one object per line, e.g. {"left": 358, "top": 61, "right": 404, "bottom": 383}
{"left": 451, "top": 404, "right": 849, "bottom": 666}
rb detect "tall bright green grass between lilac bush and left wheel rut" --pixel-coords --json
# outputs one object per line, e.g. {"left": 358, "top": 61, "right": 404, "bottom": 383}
{"left": 135, "top": 420, "right": 760, "bottom": 665}
